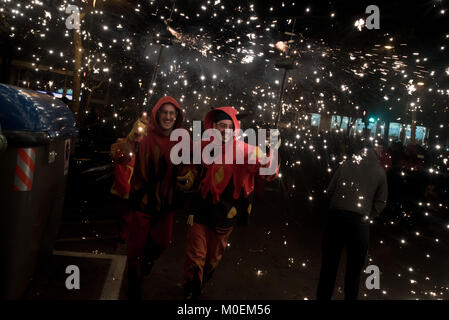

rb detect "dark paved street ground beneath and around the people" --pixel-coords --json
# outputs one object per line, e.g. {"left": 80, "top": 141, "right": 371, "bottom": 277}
{"left": 27, "top": 178, "right": 449, "bottom": 300}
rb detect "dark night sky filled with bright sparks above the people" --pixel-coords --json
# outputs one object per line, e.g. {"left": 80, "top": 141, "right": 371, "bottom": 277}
{"left": 1, "top": 0, "right": 449, "bottom": 131}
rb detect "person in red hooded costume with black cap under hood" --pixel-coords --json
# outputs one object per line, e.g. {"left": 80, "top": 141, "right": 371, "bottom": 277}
{"left": 184, "top": 107, "right": 279, "bottom": 300}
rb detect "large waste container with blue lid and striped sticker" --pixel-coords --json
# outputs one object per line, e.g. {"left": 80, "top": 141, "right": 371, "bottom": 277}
{"left": 0, "top": 84, "right": 78, "bottom": 299}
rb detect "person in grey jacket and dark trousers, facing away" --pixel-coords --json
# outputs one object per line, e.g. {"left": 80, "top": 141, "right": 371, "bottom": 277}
{"left": 317, "top": 142, "right": 388, "bottom": 300}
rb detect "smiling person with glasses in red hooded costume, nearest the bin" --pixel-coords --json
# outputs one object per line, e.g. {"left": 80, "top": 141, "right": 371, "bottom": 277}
{"left": 111, "top": 96, "right": 195, "bottom": 299}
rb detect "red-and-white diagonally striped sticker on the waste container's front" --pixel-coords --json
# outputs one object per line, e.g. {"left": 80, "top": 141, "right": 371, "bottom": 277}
{"left": 13, "top": 148, "right": 36, "bottom": 191}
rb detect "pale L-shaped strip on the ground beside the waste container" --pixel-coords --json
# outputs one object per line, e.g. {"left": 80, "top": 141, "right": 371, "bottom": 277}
{"left": 53, "top": 250, "right": 126, "bottom": 300}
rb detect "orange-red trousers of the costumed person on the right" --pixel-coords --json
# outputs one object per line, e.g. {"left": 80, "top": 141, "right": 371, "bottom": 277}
{"left": 184, "top": 223, "right": 232, "bottom": 284}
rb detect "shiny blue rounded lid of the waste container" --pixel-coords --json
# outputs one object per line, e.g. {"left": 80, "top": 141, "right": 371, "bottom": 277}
{"left": 0, "top": 83, "right": 77, "bottom": 138}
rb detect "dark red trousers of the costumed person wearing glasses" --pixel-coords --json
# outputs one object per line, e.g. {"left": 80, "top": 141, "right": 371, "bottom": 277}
{"left": 127, "top": 211, "right": 174, "bottom": 279}
